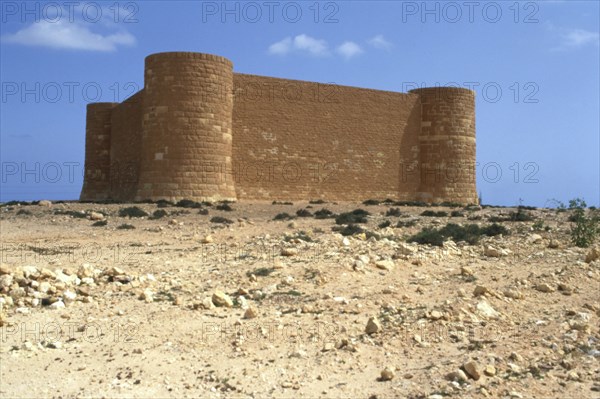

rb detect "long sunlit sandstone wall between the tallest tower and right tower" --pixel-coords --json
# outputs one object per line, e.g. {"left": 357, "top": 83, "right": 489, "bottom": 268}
{"left": 233, "top": 74, "right": 421, "bottom": 200}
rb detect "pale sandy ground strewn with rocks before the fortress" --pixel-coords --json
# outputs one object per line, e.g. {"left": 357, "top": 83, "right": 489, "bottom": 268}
{"left": 0, "top": 201, "right": 600, "bottom": 398}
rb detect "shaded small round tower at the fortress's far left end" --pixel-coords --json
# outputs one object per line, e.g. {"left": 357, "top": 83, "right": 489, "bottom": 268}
{"left": 79, "top": 103, "right": 118, "bottom": 201}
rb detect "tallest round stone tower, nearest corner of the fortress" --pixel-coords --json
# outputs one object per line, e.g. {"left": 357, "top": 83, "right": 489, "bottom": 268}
{"left": 136, "top": 52, "right": 236, "bottom": 201}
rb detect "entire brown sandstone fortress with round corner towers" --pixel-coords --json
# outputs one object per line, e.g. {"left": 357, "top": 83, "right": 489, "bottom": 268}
{"left": 80, "top": 52, "right": 478, "bottom": 204}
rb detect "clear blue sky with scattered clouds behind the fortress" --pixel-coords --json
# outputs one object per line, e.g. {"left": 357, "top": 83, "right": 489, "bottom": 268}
{"left": 0, "top": 1, "right": 600, "bottom": 206}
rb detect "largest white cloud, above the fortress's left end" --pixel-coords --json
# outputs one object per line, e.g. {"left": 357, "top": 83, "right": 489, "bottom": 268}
{"left": 2, "top": 20, "right": 136, "bottom": 51}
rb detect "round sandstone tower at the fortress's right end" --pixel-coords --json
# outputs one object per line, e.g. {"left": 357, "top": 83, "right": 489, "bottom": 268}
{"left": 410, "top": 87, "right": 479, "bottom": 204}
